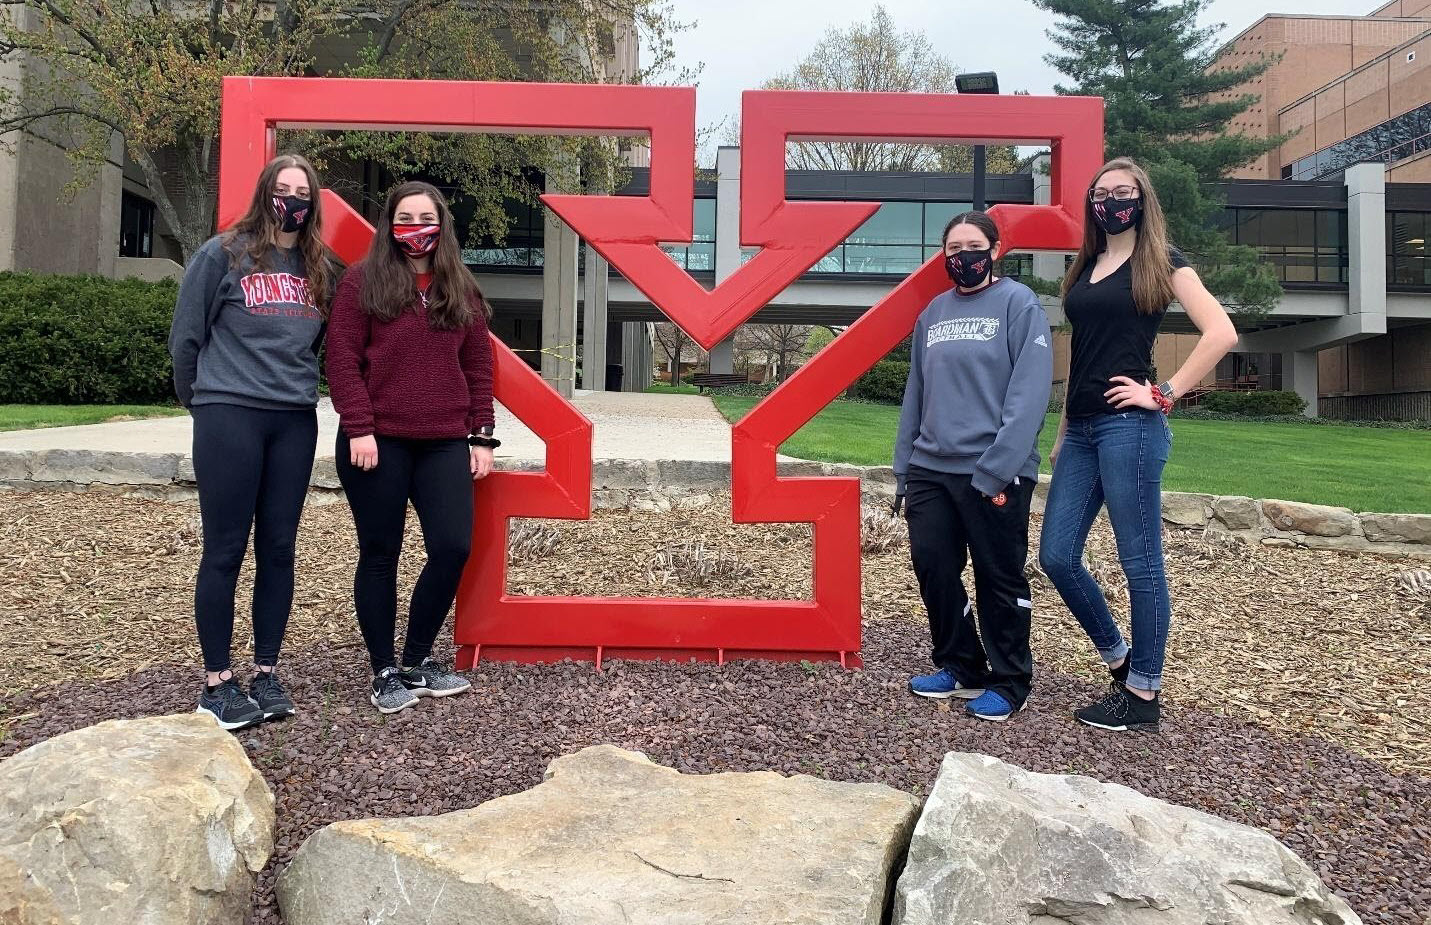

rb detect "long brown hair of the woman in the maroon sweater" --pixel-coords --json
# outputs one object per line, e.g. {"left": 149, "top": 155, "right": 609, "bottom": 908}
{"left": 362, "top": 180, "right": 492, "bottom": 331}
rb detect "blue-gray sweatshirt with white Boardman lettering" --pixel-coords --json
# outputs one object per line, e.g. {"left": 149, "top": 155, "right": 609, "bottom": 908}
{"left": 894, "top": 278, "right": 1053, "bottom": 497}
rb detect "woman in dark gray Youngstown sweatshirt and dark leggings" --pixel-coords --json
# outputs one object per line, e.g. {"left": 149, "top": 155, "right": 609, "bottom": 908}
{"left": 169, "top": 155, "right": 333, "bottom": 729}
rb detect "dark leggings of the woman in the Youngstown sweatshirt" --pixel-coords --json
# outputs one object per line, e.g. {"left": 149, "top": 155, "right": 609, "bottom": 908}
{"left": 190, "top": 405, "right": 318, "bottom": 672}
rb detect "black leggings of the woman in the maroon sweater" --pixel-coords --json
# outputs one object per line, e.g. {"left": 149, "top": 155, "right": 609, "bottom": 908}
{"left": 333, "top": 431, "right": 472, "bottom": 673}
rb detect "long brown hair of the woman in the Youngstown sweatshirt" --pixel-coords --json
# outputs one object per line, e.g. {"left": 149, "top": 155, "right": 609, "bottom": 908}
{"left": 223, "top": 155, "right": 335, "bottom": 319}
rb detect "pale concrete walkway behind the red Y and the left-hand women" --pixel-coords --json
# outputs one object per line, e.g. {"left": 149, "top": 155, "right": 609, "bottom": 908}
{"left": 0, "top": 392, "right": 730, "bottom": 463}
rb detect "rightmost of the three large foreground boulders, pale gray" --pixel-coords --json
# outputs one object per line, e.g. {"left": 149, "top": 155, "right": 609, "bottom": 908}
{"left": 893, "top": 753, "right": 1359, "bottom": 925}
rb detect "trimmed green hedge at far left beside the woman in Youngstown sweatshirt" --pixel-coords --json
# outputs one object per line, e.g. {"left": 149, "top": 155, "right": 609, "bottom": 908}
{"left": 0, "top": 272, "right": 179, "bottom": 405}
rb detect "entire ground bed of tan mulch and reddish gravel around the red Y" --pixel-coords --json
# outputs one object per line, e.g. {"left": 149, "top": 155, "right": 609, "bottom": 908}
{"left": 0, "top": 493, "right": 1431, "bottom": 925}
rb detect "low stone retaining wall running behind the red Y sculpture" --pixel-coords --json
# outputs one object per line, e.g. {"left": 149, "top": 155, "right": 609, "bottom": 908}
{"left": 0, "top": 450, "right": 1431, "bottom": 558}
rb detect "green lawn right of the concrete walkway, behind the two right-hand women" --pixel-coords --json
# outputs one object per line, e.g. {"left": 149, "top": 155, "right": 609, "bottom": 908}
{"left": 714, "top": 397, "right": 1431, "bottom": 514}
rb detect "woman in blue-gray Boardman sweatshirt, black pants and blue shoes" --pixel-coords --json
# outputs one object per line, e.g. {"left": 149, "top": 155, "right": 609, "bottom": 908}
{"left": 894, "top": 212, "right": 1053, "bottom": 720}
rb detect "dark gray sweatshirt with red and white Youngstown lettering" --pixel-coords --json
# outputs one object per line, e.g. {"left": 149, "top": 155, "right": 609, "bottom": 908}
{"left": 169, "top": 238, "right": 323, "bottom": 411}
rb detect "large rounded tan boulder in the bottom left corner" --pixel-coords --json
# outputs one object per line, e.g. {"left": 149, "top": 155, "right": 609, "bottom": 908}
{"left": 0, "top": 713, "right": 273, "bottom": 925}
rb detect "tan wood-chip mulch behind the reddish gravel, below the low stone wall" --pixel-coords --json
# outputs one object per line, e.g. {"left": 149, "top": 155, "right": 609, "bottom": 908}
{"left": 0, "top": 493, "right": 1431, "bottom": 775}
